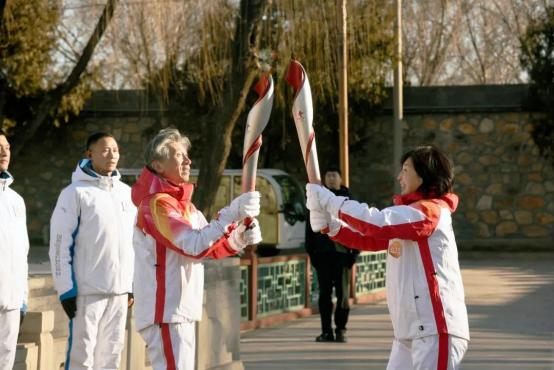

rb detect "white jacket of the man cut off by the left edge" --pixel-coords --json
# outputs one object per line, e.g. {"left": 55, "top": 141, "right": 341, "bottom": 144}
{"left": 0, "top": 172, "right": 29, "bottom": 310}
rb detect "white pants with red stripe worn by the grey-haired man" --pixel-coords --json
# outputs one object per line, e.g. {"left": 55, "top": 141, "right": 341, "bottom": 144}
{"left": 139, "top": 322, "right": 196, "bottom": 370}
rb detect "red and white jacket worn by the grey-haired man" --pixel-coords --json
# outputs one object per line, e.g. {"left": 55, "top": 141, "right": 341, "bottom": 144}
{"left": 132, "top": 168, "right": 237, "bottom": 330}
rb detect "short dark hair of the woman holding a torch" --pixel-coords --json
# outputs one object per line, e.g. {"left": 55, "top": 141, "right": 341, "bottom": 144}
{"left": 400, "top": 145, "right": 454, "bottom": 197}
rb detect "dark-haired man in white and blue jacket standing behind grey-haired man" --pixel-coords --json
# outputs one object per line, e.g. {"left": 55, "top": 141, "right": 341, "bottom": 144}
{"left": 50, "top": 132, "right": 136, "bottom": 369}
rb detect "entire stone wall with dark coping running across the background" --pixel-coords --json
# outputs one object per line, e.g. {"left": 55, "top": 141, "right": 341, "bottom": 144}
{"left": 10, "top": 85, "right": 554, "bottom": 250}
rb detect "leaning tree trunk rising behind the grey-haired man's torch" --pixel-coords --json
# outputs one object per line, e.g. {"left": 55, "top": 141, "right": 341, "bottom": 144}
{"left": 195, "top": 0, "right": 271, "bottom": 217}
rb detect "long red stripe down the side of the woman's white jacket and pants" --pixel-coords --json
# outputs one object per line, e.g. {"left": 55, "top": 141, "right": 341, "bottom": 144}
{"left": 418, "top": 239, "right": 448, "bottom": 370}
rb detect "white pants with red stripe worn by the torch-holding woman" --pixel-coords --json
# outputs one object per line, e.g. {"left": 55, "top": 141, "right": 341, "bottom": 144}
{"left": 387, "top": 335, "right": 468, "bottom": 370}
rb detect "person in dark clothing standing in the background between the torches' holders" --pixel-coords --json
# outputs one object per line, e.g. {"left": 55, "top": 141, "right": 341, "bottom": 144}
{"left": 305, "top": 167, "right": 359, "bottom": 343}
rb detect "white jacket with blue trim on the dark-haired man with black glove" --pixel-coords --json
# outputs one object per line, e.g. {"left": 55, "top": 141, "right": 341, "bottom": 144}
{"left": 49, "top": 159, "right": 136, "bottom": 300}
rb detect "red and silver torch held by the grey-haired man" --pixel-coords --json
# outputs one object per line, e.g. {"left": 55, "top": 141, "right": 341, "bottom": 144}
{"left": 241, "top": 74, "right": 273, "bottom": 226}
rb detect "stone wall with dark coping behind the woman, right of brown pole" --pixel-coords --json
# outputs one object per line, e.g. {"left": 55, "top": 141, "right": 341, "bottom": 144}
{"left": 350, "top": 86, "right": 554, "bottom": 250}
